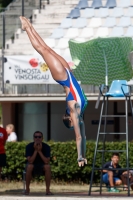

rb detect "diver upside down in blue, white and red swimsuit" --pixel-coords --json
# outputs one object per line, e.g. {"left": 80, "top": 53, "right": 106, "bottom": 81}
{"left": 20, "top": 17, "right": 87, "bottom": 167}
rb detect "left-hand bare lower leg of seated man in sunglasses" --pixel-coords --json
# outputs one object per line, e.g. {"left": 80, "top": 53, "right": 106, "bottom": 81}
{"left": 25, "top": 164, "right": 34, "bottom": 194}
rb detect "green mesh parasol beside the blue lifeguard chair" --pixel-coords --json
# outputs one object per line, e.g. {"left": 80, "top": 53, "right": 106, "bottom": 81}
{"left": 69, "top": 37, "right": 133, "bottom": 85}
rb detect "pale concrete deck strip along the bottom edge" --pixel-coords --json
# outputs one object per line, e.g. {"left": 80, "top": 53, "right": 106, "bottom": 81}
{"left": 0, "top": 192, "right": 133, "bottom": 200}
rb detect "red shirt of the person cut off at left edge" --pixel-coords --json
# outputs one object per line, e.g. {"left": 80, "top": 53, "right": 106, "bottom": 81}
{"left": 0, "top": 127, "right": 7, "bottom": 154}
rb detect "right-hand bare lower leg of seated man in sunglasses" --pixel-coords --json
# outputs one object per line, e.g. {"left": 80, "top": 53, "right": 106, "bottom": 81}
{"left": 44, "top": 164, "right": 52, "bottom": 194}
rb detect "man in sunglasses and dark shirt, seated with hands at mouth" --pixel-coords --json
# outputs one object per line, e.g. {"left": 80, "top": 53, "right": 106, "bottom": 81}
{"left": 24, "top": 131, "right": 52, "bottom": 195}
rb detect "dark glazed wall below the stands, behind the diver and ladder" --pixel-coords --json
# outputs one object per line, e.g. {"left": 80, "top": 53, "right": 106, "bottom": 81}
{"left": 3, "top": 101, "right": 133, "bottom": 142}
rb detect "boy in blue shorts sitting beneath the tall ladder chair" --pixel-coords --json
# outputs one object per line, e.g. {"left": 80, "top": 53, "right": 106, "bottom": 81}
{"left": 102, "top": 153, "right": 123, "bottom": 192}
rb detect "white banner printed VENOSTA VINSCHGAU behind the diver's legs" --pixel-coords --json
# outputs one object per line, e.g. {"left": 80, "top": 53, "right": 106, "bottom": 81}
{"left": 4, "top": 55, "right": 57, "bottom": 84}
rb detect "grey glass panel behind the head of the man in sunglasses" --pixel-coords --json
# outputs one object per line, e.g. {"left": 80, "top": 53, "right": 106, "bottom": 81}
{"left": 18, "top": 102, "right": 47, "bottom": 141}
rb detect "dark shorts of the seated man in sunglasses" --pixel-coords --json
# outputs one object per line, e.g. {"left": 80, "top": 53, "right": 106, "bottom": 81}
{"left": 25, "top": 164, "right": 45, "bottom": 176}
